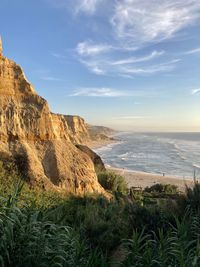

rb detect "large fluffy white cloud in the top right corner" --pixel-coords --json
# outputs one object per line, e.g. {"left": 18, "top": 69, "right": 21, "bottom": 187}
{"left": 111, "top": 0, "right": 200, "bottom": 45}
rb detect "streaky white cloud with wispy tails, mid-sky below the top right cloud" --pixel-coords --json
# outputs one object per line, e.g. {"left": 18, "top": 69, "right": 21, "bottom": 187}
{"left": 75, "top": 33, "right": 178, "bottom": 78}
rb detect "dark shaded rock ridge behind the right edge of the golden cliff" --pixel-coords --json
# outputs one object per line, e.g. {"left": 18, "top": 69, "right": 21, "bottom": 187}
{"left": 76, "top": 145, "right": 106, "bottom": 173}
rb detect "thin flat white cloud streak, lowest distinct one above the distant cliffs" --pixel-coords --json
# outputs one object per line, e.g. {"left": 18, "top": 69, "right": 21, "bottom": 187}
{"left": 71, "top": 88, "right": 128, "bottom": 97}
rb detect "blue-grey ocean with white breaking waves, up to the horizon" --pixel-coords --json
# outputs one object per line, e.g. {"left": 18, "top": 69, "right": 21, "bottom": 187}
{"left": 95, "top": 132, "right": 200, "bottom": 178}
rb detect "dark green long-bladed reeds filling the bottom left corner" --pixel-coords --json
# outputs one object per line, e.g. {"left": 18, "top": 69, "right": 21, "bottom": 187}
{"left": 0, "top": 184, "right": 106, "bottom": 267}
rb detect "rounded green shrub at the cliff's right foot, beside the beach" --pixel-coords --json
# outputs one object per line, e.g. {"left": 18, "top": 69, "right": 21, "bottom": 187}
{"left": 98, "top": 172, "right": 128, "bottom": 195}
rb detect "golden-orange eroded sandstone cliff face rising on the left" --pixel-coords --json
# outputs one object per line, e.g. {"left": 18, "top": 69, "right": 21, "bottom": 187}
{"left": 0, "top": 45, "right": 105, "bottom": 194}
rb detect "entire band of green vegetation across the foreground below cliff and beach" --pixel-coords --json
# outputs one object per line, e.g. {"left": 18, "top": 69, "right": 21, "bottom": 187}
{"left": 0, "top": 162, "right": 200, "bottom": 267}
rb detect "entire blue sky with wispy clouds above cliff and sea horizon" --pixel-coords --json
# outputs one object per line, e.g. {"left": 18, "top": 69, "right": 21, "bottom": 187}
{"left": 0, "top": 0, "right": 200, "bottom": 132}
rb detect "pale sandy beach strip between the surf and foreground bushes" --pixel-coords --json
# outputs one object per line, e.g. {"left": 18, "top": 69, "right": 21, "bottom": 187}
{"left": 106, "top": 166, "right": 193, "bottom": 192}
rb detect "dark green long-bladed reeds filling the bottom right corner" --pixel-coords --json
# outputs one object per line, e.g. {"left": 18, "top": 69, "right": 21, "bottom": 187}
{"left": 121, "top": 214, "right": 200, "bottom": 267}
